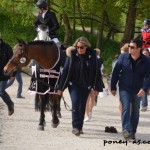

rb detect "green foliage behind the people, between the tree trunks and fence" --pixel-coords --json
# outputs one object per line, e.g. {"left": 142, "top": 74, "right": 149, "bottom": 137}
{"left": 0, "top": 0, "right": 150, "bottom": 74}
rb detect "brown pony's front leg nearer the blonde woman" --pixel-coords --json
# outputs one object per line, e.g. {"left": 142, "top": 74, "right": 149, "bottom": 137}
{"left": 50, "top": 94, "right": 60, "bottom": 128}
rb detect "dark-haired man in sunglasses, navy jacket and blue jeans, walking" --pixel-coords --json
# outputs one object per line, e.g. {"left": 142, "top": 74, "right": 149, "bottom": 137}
{"left": 111, "top": 39, "right": 150, "bottom": 140}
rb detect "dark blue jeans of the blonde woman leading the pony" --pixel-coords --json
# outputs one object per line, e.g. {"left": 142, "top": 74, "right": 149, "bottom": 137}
{"left": 68, "top": 83, "right": 90, "bottom": 129}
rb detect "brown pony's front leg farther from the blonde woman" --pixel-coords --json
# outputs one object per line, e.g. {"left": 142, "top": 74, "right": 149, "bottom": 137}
{"left": 38, "top": 95, "right": 45, "bottom": 130}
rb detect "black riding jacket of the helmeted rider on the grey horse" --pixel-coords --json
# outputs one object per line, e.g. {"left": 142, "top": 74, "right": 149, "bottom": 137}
{"left": 34, "top": 10, "right": 60, "bottom": 39}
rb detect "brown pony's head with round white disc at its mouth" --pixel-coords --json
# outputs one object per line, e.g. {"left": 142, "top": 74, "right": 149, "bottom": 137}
{"left": 4, "top": 40, "right": 30, "bottom": 76}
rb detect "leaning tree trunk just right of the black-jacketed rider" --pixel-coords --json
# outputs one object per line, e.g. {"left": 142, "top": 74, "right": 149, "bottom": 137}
{"left": 62, "top": 13, "right": 72, "bottom": 44}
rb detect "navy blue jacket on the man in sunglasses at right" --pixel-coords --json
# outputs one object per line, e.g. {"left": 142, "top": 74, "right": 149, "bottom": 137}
{"left": 111, "top": 52, "right": 150, "bottom": 94}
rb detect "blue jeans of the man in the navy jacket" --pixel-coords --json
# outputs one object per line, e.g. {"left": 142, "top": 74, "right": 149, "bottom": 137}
{"left": 119, "top": 90, "right": 141, "bottom": 133}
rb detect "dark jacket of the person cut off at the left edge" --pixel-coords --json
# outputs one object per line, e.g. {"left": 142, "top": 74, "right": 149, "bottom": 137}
{"left": 0, "top": 39, "right": 13, "bottom": 81}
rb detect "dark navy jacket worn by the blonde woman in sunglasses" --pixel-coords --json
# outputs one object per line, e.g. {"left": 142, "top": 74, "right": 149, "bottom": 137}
{"left": 58, "top": 48, "right": 103, "bottom": 92}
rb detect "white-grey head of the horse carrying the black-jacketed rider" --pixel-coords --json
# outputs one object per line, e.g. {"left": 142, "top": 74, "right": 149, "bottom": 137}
{"left": 35, "top": 25, "right": 51, "bottom": 41}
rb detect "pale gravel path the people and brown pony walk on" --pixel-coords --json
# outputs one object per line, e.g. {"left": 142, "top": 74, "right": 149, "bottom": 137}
{"left": 0, "top": 75, "right": 150, "bottom": 150}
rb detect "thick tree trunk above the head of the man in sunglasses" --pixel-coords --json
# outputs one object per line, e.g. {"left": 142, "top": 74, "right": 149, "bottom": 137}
{"left": 122, "top": 0, "right": 138, "bottom": 43}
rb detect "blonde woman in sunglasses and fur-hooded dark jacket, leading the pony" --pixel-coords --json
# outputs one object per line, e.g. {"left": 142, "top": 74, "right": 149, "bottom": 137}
{"left": 57, "top": 37, "right": 103, "bottom": 136}
